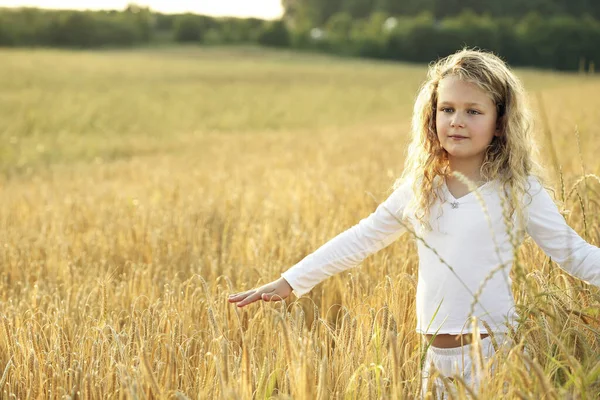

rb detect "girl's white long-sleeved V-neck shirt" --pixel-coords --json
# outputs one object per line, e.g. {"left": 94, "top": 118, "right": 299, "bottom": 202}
{"left": 281, "top": 176, "right": 600, "bottom": 334}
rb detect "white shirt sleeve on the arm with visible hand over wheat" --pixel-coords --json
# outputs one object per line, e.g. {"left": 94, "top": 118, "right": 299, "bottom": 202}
{"left": 281, "top": 182, "right": 410, "bottom": 297}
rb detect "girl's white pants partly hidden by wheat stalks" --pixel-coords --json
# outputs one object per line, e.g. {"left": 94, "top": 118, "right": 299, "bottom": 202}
{"left": 421, "top": 333, "right": 514, "bottom": 399}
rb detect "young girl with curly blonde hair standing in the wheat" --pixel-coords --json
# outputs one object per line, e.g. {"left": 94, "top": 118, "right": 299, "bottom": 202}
{"left": 229, "top": 49, "right": 600, "bottom": 396}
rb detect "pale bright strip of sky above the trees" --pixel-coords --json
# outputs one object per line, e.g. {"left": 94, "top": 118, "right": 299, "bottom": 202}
{"left": 0, "top": 0, "right": 283, "bottom": 19}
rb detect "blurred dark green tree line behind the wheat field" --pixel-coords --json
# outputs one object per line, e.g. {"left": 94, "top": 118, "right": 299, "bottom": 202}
{"left": 0, "top": 4, "right": 600, "bottom": 71}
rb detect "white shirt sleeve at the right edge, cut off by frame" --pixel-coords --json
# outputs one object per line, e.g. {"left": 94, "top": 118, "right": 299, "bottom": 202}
{"left": 526, "top": 178, "right": 600, "bottom": 286}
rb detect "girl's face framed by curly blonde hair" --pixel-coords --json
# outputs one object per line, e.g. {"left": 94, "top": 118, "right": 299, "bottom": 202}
{"left": 435, "top": 76, "right": 500, "bottom": 165}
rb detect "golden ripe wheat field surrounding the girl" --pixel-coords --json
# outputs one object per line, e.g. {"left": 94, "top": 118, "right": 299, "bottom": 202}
{"left": 0, "top": 47, "right": 600, "bottom": 399}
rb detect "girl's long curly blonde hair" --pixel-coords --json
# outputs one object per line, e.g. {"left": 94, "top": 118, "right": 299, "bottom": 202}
{"left": 394, "top": 48, "right": 545, "bottom": 230}
